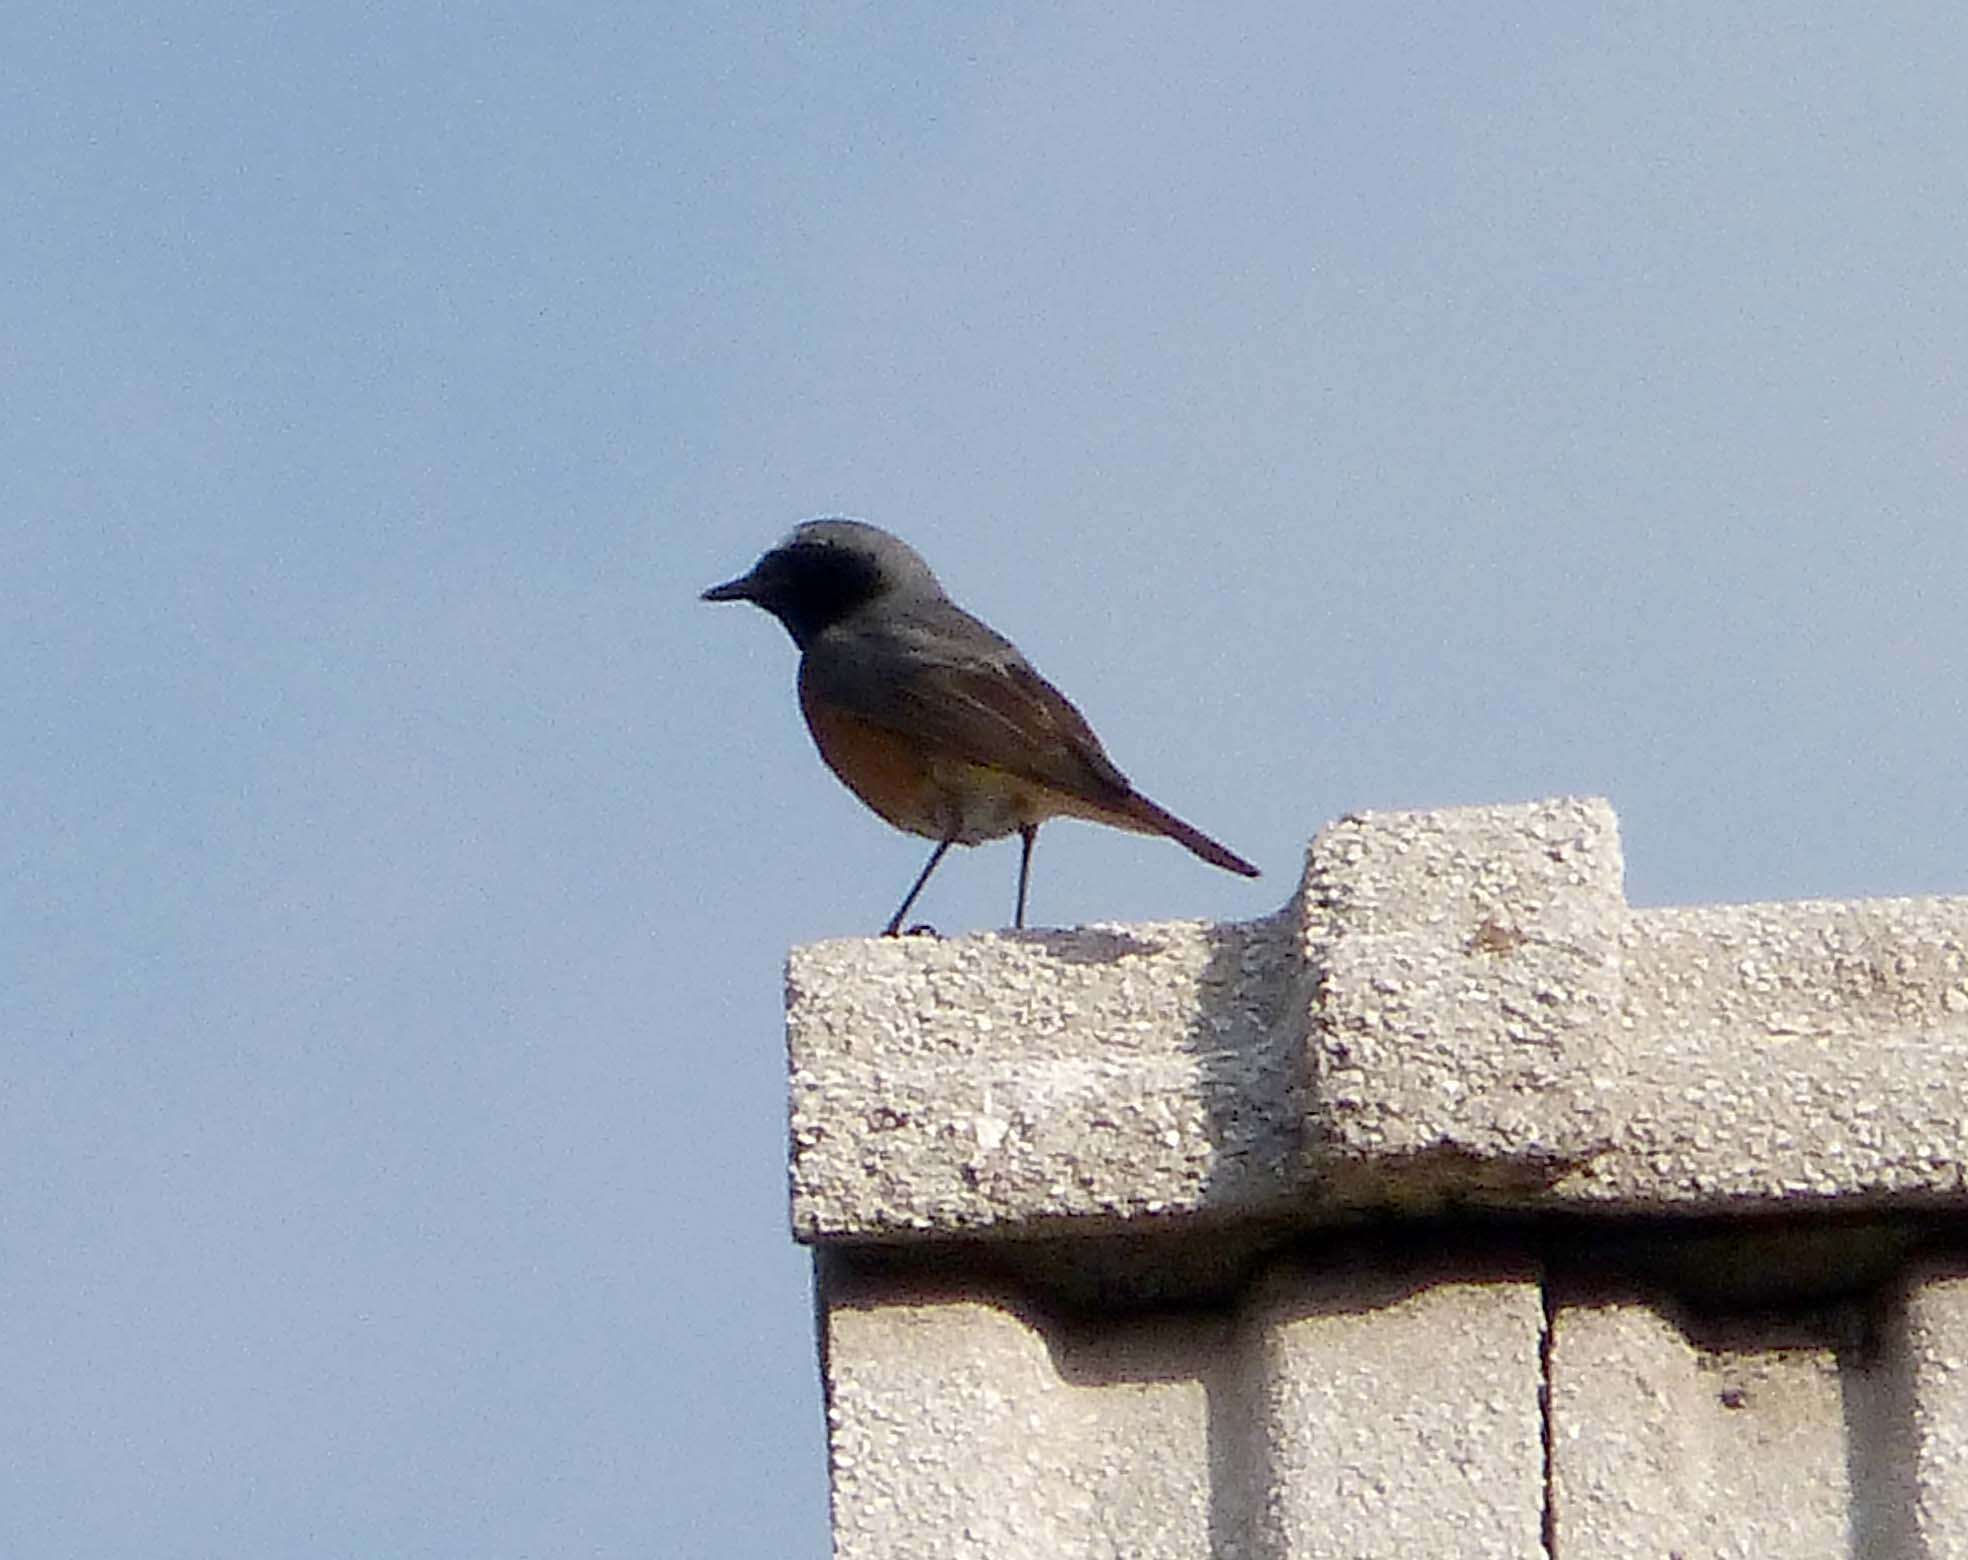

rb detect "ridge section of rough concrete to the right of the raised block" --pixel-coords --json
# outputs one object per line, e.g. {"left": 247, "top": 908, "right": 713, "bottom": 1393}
{"left": 1557, "top": 899, "right": 1968, "bottom": 1212}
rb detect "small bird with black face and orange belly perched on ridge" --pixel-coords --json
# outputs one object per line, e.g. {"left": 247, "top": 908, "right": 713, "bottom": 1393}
{"left": 703, "top": 517, "right": 1258, "bottom": 936}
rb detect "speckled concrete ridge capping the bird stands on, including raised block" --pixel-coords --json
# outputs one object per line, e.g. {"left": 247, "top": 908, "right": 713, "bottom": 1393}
{"left": 787, "top": 801, "right": 1968, "bottom": 1239}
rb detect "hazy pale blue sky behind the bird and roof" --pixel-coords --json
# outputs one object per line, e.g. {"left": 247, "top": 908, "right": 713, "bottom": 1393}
{"left": 0, "top": 4, "right": 1968, "bottom": 1560}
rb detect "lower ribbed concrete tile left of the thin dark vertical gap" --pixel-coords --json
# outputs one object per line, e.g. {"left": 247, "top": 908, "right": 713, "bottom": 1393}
{"left": 823, "top": 1265, "right": 1543, "bottom": 1560}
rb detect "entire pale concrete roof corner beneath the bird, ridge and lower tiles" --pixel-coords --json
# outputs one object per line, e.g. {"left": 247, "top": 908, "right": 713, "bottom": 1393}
{"left": 787, "top": 801, "right": 1968, "bottom": 1560}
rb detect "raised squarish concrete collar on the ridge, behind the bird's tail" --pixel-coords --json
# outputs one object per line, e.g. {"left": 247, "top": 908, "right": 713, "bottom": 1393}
{"left": 1297, "top": 801, "right": 1628, "bottom": 1204}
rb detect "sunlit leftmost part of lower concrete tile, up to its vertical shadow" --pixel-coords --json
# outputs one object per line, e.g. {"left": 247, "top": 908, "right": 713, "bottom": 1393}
{"left": 825, "top": 1277, "right": 1220, "bottom": 1560}
